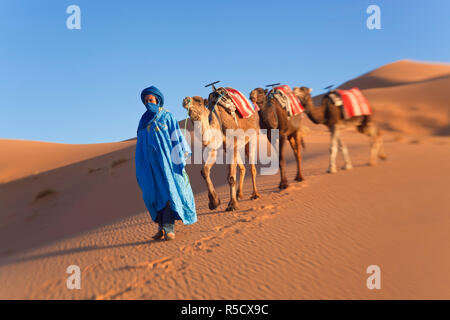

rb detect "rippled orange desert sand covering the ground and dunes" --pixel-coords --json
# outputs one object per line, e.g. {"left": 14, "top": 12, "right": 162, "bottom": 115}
{"left": 0, "top": 61, "right": 450, "bottom": 299}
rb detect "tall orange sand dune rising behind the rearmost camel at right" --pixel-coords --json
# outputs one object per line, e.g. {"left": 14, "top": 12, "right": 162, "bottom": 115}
{"left": 314, "top": 60, "right": 450, "bottom": 137}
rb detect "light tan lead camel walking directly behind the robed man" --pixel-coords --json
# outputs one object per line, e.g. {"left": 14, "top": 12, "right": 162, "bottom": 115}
{"left": 183, "top": 92, "right": 260, "bottom": 211}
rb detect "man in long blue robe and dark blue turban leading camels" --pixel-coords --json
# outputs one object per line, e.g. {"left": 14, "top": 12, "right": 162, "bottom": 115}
{"left": 135, "top": 86, "right": 197, "bottom": 240}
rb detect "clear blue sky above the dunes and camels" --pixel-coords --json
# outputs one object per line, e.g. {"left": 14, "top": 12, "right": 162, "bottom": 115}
{"left": 0, "top": 0, "right": 450, "bottom": 143}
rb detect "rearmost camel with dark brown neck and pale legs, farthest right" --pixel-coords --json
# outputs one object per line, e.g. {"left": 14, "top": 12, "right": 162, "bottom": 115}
{"left": 293, "top": 87, "right": 387, "bottom": 173}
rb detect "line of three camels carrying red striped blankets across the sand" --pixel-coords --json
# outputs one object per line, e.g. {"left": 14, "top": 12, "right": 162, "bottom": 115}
{"left": 183, "top": 81, "right": 386, "bottom": 211}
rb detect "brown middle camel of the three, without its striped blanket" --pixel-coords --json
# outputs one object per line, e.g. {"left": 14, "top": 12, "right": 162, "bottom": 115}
{"left": 250, "top": 88, "right": 304, "bottom": 189}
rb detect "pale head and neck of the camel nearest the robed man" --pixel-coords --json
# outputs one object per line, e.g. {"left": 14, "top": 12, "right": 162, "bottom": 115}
{"left": 183, "top": 96, "right": 218, "bottom": 146}
